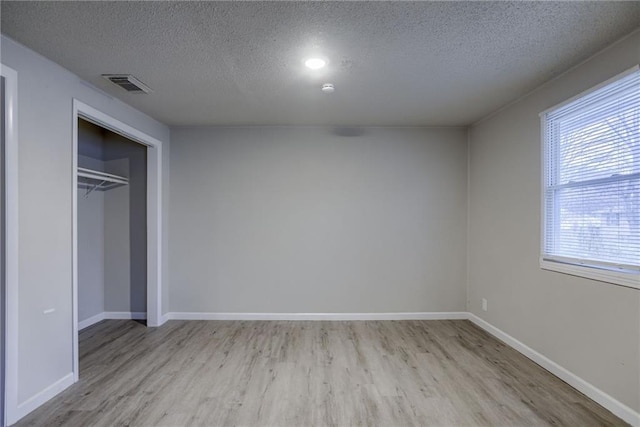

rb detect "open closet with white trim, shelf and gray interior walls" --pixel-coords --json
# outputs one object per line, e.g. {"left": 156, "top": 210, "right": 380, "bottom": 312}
{"left": 72, "top": 100, "right": 162, "bottom": 381}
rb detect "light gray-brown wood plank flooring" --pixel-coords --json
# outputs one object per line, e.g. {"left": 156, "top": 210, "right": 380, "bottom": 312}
{"left": 13, "top": 320, "right": 624, "bottom": 427}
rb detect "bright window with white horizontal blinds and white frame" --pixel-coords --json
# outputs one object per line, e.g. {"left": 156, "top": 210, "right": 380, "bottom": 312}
{"left": 541, "top": 67, "right": 640, "bottom": 288}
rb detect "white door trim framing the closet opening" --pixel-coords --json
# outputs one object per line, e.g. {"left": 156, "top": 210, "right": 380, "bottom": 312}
{"left": 71, "top": 99, "right": 162, "bottom": 381}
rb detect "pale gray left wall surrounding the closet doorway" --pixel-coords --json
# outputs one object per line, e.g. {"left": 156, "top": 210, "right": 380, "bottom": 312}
{"left": 0, "top": 36, "right": 169, "bottom": 416}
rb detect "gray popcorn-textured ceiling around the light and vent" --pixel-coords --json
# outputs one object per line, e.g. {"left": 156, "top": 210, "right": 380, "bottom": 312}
{"left": 0, "top": 1, "right": 640, "bottom": 126}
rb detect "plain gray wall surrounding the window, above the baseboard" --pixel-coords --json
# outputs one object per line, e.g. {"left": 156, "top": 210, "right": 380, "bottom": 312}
{"left": 468, "top": 33, "right": 640, "bottom": 411}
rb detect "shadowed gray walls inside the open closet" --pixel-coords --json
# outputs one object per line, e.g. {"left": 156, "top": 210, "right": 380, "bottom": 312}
{"left": 77, "top": 119, "right": 147, "bottom": 322}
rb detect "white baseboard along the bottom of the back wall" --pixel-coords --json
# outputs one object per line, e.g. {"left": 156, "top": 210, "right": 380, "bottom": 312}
{"left": 163, "top": 311, "right": 468, "bottom": 321}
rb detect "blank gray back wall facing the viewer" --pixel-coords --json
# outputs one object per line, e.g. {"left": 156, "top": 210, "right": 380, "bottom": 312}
{"left": 169, "top": 127, "right": 467, "bottom": 313}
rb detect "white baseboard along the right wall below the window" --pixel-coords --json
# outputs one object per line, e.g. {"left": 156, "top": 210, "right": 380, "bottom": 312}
{"left": 468, "top": 313, "right": 640, "bottom": 427}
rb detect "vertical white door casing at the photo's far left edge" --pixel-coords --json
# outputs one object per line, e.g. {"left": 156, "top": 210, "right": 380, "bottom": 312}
{"left": 0, "top": 64, "right": 19, "bottom": 424}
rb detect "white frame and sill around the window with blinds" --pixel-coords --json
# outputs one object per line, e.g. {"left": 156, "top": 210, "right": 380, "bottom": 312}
{"left": 539, "top": 65, "right": 640, "bottom": 289}
